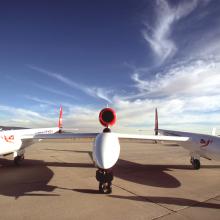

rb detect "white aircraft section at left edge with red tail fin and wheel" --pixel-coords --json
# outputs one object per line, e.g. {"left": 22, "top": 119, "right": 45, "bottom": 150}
{"left": 0, "top": 107, "right": 63, "bottom": 165}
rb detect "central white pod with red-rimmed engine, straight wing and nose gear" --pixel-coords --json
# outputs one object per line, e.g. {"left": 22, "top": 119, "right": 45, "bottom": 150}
{"left": 34, "top": 108, "right": 190, "bottom": 193}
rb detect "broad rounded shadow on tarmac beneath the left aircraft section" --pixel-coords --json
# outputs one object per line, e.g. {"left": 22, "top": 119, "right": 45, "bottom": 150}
{"left": 0, "top": 159, "right": 94, "bottom": 199}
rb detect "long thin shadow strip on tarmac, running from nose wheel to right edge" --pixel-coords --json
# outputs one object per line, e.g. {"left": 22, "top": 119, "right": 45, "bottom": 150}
{"left": 109, "top": 195, "right": 220, "bottom": 209}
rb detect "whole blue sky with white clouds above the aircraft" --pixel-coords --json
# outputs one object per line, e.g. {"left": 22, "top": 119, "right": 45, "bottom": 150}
{"left": 0, "top": 0, "right": 220, "bottom": 133}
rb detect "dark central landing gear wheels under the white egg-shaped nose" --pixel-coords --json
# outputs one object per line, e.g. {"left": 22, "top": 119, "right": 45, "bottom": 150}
{"left": 96, "top": 169, "right": 113, "bottom": 194}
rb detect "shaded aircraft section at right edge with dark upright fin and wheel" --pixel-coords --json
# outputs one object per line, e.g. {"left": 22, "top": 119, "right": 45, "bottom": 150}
{"left": 155, "top": 109, "right": 220, "bottom": 169}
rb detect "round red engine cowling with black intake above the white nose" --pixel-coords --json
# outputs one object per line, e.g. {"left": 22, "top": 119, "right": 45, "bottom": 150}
{"left": 99, "top": 108, "right": 116, "bottom": 127}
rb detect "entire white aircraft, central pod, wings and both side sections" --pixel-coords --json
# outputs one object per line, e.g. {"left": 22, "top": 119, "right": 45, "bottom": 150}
{"left": 0, "top": 108, "right": 220, "bottom": 193}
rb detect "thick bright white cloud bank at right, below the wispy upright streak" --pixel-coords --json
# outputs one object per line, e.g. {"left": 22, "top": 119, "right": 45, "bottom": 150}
{"left": 132, "top": 60, "right": 220, "bottom": 98}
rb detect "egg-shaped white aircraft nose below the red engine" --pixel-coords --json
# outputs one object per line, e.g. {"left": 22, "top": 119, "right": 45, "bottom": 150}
{"left": 93, "top": 133, "right": 120, "bottom": 169}
